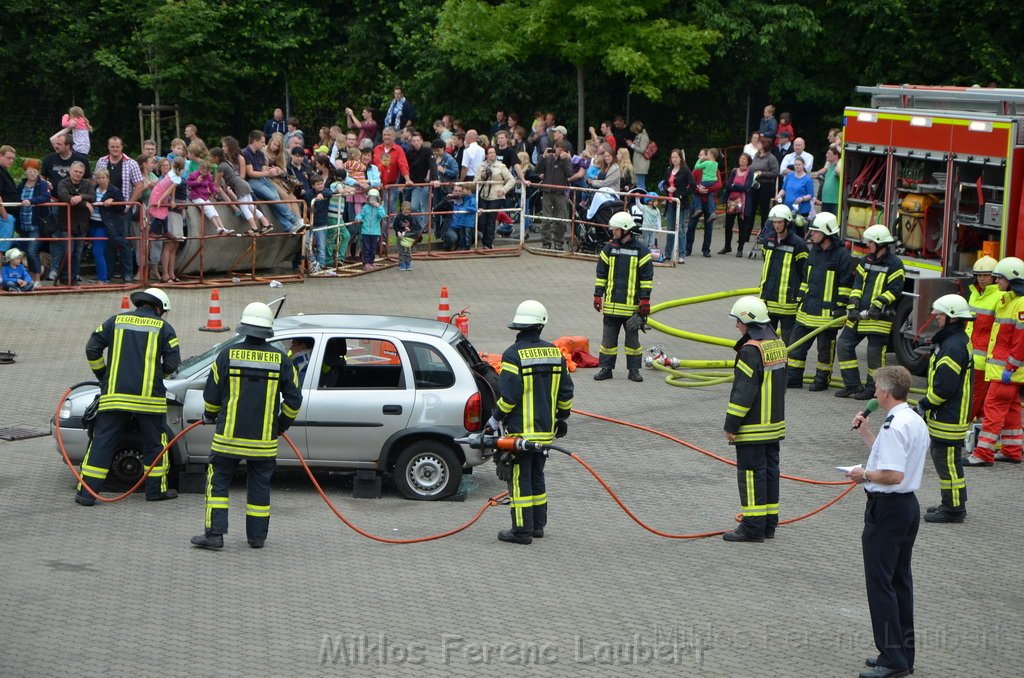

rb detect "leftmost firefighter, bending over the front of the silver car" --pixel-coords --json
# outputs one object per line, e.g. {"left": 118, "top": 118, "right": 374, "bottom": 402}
{"left": 75, "top": 288, "right": 181, "bottom": 506}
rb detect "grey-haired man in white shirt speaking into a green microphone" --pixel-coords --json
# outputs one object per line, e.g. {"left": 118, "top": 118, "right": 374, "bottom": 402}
{"left": 847, "top": 367, "right": 930, "bottom": 678}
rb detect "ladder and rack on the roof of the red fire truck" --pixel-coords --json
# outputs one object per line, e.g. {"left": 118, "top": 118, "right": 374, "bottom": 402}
{"left": 857, "top": 85, "right": 1024, "bottom": 116}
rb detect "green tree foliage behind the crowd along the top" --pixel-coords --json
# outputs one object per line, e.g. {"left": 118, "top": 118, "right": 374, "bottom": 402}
{"left": 0, "top": 0, "right": 1024, "bottom": 157}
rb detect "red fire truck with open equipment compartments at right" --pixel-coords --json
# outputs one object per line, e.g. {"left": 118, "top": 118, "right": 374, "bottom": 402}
{"left": 839, "top": 85, "right": 1024, "bottom": 374}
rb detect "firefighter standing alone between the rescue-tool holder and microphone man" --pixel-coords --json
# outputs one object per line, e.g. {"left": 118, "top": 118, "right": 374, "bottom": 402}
{"left": 722, "top": 297, "right": 786, "bottom": 542}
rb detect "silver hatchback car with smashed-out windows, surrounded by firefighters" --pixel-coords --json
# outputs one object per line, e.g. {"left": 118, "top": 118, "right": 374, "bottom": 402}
{"left": 51, "top": 314, "right": 497, "bottom": 500}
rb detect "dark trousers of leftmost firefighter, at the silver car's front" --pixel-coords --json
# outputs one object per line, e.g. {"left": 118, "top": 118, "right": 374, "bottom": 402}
{"left": 78, "top": 410, "right": 171, "bottom": 499}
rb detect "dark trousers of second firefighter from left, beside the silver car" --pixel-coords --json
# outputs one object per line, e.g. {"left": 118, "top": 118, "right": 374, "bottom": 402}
{"left": 206, "top": 452, "right": 278, "bottom": 541}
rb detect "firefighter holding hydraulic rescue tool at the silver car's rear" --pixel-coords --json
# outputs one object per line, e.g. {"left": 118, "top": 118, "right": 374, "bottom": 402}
{"left": 487, "top": 299, "right": 572, "bottom": 544}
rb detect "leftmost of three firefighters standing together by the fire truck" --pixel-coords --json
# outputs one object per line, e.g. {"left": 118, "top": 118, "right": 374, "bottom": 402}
{"left": 760, "top": 205, "right": 807, "bottom": 343}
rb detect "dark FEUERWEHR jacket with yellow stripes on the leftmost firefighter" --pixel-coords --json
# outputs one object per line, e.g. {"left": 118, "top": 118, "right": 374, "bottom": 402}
{"left": 85, "top": 306, "right": 181, "bottom": 415}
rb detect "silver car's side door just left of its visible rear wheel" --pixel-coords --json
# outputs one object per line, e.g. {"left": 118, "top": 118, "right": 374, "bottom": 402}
{"left": 299, "top": 332, "right": 416, "bottom": 468}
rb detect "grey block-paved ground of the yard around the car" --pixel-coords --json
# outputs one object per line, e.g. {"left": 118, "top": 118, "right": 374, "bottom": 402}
{"left": 0, "top": 246, "right": 1024, "bottom": 677}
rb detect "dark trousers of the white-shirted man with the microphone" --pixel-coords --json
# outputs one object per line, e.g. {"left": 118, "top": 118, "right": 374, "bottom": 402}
{"left": 860, "top": 493, "right": 921, "bottom": 670}
